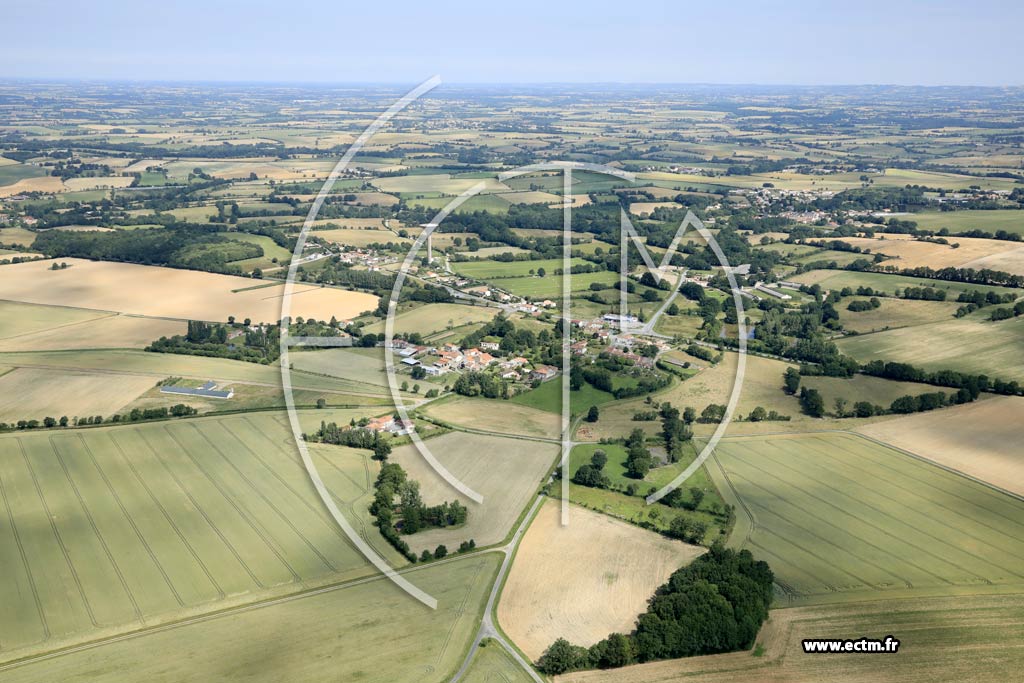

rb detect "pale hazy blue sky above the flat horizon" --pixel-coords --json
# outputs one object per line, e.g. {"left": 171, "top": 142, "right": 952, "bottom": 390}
{"left": 8, "top": 0, "right": 1024, "bottom": 85}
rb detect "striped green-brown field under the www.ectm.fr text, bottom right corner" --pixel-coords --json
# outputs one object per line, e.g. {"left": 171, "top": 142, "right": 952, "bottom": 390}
{"left": 555, "top": 595, "right": 1024, "bottom": 683}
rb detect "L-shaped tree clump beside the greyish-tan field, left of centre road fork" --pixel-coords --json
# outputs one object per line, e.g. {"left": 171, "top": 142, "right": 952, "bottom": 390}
{"left": 370, "top": 463, "right": 476, "bottom": 562}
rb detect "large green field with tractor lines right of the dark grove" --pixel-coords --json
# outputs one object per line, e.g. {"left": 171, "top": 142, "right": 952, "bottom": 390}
{"left": 711, "top": 433, "right": 1024, "bottom": 603}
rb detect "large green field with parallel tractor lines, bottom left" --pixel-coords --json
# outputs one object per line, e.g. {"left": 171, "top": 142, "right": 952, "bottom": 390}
{"left": 0, "top": 413, "right": 389, "bottom": 663}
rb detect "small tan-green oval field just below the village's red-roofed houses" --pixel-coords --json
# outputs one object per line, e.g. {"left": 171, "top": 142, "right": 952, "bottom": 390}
{"left": 424, "top": 396, "right": 561, "bottom": 438}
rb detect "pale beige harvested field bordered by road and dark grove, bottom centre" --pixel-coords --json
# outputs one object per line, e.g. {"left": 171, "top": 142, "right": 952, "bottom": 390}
{"left": 498, "top": 500, "right": 705, "bottom": 659}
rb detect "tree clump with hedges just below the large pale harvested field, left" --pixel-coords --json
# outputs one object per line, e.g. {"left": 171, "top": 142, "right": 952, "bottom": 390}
{"left": 145, "top": 318, "right": 281, "bottom": 365}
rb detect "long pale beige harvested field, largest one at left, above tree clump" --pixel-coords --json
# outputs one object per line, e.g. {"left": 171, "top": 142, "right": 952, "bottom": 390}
{"left": 0, "top": 258, "right": 377, "bottom": 323}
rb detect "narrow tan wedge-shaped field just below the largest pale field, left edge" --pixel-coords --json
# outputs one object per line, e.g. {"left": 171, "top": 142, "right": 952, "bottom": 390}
{"left": 0, "top": 311, "right": 186, "bottom": 351}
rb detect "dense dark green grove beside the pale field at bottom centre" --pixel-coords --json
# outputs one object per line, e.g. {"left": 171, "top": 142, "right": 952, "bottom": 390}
{"left": 537, "top": 544, "right": 774, "bottom": 676}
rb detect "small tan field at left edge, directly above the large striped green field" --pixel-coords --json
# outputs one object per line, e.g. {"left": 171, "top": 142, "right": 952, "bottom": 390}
{"left": 0, "top": 368, "right": 155, "bottom": 422}
